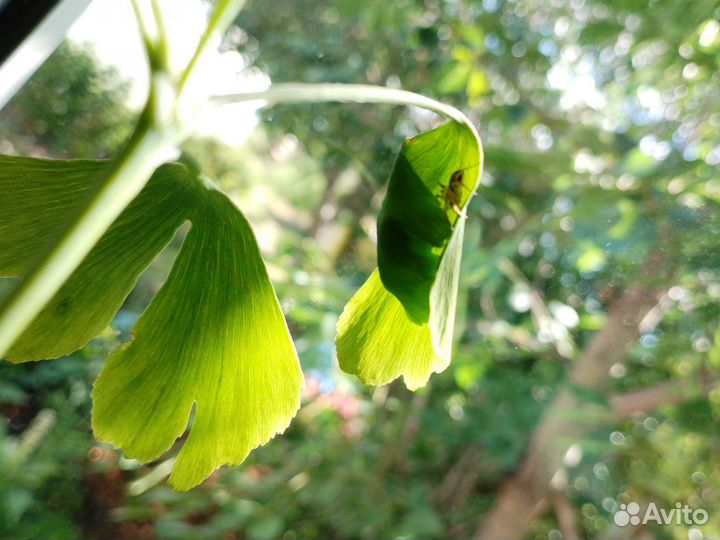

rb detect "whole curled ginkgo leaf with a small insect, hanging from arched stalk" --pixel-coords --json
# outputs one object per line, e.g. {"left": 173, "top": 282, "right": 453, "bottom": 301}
{"left": 337, "top": 122, "right": 482, "bottom": 390}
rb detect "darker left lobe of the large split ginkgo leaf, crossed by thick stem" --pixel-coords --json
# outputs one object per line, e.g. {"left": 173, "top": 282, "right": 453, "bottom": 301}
{"left": 0, "top": 158, "right": 191, "bottom": 362}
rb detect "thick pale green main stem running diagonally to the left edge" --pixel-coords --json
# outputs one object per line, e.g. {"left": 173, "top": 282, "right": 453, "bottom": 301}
{"left": 0, "top": 115, "right": 175, "bottom": 358}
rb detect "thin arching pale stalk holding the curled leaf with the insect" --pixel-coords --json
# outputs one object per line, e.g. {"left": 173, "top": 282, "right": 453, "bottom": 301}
{"left": 213, "top": 83, "right": 479, "bottom": 138}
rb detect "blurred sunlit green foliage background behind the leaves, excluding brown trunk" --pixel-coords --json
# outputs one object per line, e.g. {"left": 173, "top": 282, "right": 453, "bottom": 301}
{"left": 0, "top": 0, "right": 720, "bottom": 539}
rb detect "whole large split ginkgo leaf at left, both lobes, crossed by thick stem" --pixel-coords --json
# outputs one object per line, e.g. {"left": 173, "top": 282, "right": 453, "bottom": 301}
{"left": 0, "top": 152, "right": 302, "bottom": 489}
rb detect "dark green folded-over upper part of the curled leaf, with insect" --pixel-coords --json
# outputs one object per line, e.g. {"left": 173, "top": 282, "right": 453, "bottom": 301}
{"left": 378, "top": 122, "right": 482, "bottom": 323}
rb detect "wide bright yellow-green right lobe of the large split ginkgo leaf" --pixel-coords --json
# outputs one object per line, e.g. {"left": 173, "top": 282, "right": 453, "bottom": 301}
{"left": 93, "top": 190, "right": 302, "bottom": 490}
